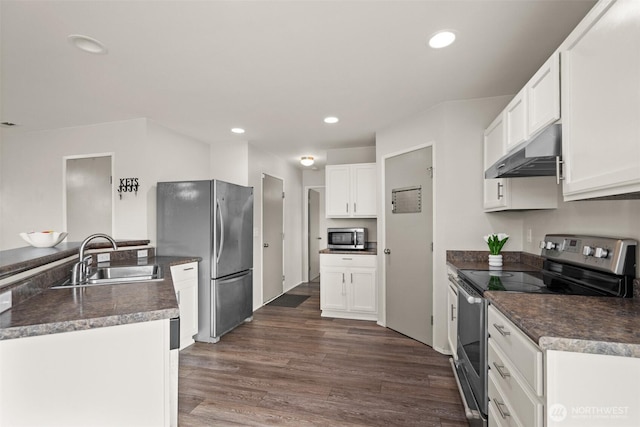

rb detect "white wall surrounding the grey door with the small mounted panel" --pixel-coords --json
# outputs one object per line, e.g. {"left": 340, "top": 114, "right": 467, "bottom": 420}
{"left": 376, "top": 96, "right": 522, "bottom": 351}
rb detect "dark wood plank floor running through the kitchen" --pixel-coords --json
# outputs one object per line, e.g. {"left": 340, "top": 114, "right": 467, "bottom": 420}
{"left": 179, "top": 283, "right": 467, "bottom": 427}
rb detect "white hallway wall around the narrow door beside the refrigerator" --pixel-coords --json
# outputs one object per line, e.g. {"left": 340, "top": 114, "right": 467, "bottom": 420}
{"left": 249, "top": 143, "right": 303, "bottom": 310}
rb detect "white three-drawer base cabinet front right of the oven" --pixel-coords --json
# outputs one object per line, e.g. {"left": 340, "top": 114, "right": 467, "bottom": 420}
{"left": 487, "top": 306, "right": 544, "bottom": 427}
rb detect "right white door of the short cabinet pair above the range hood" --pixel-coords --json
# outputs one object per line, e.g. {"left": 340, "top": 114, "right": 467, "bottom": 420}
{"left": 527, "top": 52, "right": 560, "bottom": 135}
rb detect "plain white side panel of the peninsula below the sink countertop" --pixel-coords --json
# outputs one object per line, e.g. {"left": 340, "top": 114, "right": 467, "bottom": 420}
{"left": 0, "top": 319, "right": 172, "bottom": 427}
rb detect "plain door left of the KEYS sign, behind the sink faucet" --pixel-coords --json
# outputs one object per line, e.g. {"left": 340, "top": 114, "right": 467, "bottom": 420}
{"left": 65, "top": 156, "right": 113, "bottom": 242}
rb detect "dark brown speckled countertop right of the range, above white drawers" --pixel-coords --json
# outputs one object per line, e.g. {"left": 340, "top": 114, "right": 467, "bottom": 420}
{"left": 485, "top": 291, "right": 640, "bottom": 357}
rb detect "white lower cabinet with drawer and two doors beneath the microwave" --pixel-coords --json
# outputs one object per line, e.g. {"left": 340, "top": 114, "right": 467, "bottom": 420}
{"left": 320, "top": 254, "right": 378, "bottom": 320}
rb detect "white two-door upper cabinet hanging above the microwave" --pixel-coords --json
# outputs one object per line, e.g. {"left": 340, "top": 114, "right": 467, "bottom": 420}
{"left": 325, "top": 163, "right": 377, "bottom": 218}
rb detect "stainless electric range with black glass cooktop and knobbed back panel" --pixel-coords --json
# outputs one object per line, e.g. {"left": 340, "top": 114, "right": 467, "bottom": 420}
{"left": 450, "top": 234, "right": 638, "bottom": 426}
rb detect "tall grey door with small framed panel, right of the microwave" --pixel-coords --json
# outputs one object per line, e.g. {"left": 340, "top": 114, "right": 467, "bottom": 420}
{"left": 384, "top": 147, "right": 433, "bottom": 345}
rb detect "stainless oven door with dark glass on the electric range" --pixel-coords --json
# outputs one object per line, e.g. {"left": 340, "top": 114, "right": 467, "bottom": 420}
{"left": 456, "top": 279, "right": 488, "bottom": 420}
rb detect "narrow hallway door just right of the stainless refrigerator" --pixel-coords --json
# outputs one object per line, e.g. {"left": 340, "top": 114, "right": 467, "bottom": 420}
{"left": 262, "top": 174, "right": 284, "bottom": 303}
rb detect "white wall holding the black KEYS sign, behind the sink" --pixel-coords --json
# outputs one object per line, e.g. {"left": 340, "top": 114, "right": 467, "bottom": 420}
{"left": 0, "top": 119, "right": 210, "bottom": 250}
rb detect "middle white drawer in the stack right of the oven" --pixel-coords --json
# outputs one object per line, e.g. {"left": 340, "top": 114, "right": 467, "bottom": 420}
{"left": 489, "top": 339, "right": 543, "bottom": 427}
